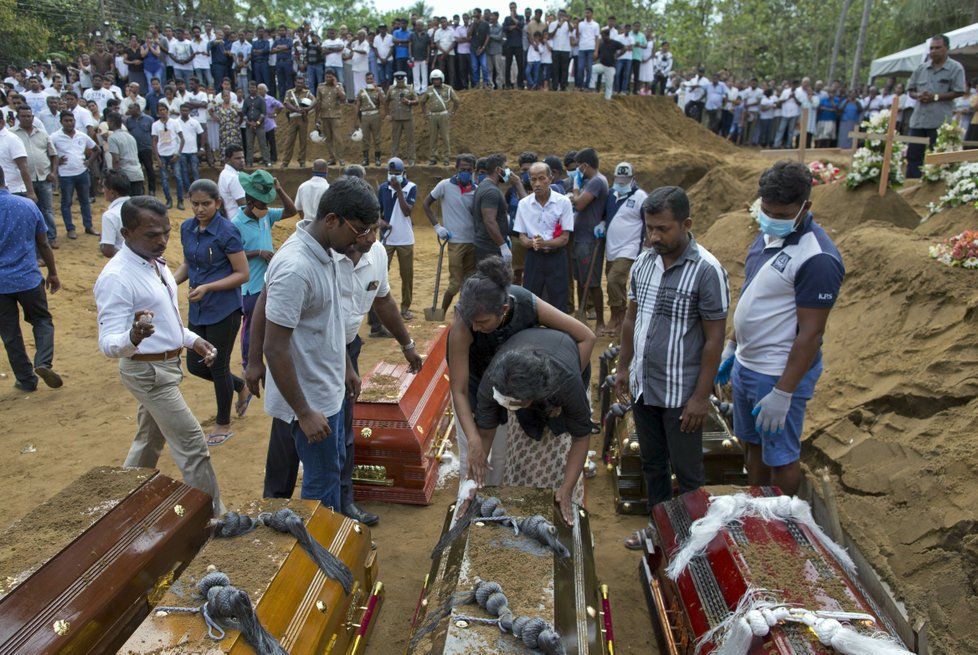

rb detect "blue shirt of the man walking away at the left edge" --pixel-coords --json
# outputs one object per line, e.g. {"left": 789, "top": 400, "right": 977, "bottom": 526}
{"left": 0, "top": 189, "right": 47, "bottom": 293}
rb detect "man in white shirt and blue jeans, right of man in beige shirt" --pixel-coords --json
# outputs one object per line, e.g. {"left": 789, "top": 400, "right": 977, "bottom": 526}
{"left": 51, "top": 111, "right": 99, "bottom": 239}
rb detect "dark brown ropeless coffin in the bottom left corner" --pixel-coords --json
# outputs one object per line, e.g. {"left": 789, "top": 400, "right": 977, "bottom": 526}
{"left": 0, "top": 467, "right": 213, "bottom": 655}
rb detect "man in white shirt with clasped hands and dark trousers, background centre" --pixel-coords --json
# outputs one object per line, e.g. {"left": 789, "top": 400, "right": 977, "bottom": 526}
{"left": 513, "top": 162, "right": 574, "bottom": 312}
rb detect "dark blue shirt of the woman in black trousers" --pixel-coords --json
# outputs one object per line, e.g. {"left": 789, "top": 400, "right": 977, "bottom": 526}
{"left": 180, "top": 214, "right": 244, "bottom": 325}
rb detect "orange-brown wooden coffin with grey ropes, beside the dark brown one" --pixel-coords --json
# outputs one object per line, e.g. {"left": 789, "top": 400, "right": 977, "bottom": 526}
{"left": 119, "top": 499, "right": 383, "bottom": 655}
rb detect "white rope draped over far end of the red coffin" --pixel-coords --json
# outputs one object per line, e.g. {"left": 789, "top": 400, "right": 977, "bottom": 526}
{"left": 666, "top": 493, "right": 856, "bottom": 580}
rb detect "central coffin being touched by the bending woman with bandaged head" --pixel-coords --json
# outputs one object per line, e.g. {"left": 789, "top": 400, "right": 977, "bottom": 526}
{"left": 407, "top": 487, "right": 613, "bottom": 655}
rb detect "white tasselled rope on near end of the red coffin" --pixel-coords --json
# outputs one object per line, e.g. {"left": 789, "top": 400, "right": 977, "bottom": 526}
{"left": 695, "top": 588, "right": 910, "bottom": 655}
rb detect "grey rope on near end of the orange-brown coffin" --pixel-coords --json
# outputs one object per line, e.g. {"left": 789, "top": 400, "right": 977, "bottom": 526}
{"left": 156, "top": 571, "right": 289, "bottom": 655}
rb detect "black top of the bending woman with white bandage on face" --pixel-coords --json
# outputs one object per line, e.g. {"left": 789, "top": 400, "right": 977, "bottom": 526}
{"left": 475, "top": 327, "right": 591, "bottom": 440}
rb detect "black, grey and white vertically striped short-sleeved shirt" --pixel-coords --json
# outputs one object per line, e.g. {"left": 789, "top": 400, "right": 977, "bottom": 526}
{"left": 628, "top": 235, "right": 730, "bottom": 408}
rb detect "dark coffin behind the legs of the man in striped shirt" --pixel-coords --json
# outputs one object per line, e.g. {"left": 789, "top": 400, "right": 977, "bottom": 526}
{"left": 604, "top": 404, "right": 747, "bottom": 514}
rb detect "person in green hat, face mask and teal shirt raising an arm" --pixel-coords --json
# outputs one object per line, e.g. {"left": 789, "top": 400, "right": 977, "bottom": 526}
{"left": 233, "top": 169, "right": 296, "bottom": 376}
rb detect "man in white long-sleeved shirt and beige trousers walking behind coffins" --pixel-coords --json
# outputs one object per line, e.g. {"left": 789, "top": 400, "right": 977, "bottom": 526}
{"left": 95, "top": 196, "right": 224, "bottom": 517}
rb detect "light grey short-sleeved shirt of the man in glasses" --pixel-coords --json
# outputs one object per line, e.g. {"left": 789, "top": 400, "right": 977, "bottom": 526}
{"left": 265, "top": 225, "right": 346, "bottom": 423}
